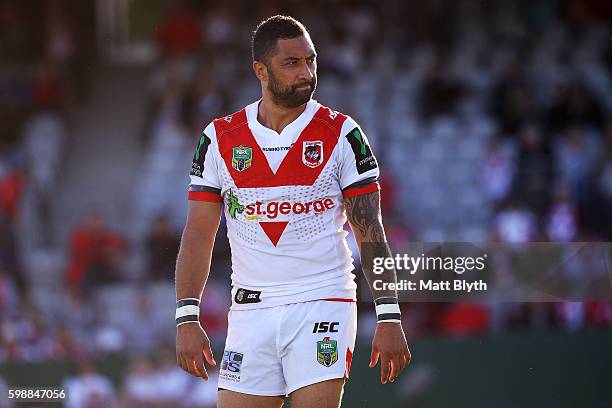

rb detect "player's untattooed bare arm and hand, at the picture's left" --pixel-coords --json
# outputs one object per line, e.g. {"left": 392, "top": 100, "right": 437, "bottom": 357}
{"left": 176, "top": 201, "right": 221, "bottom": 380}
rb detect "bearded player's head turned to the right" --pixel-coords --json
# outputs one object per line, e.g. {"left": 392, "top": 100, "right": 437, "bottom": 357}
{"left": 252, "top": 16, "right": 317, "bottom": 108}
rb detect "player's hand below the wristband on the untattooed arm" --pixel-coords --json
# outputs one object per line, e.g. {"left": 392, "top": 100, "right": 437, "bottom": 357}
{"left": 176, "top": 322, "right": 217, "bottom": 381}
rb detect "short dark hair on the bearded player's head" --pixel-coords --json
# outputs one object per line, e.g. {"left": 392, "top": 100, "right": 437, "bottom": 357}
{"left": 251, "top": 15, "right": 309, "bottom": 64}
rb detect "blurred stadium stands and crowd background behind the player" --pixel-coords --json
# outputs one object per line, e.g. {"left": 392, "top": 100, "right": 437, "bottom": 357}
{"left": 0, "top": 0, "right": 612, "bottom": 408}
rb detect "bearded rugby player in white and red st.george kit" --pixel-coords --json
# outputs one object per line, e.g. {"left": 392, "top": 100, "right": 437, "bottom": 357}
{"left": 176, "top": 16, "right": 410, "bottom": 408}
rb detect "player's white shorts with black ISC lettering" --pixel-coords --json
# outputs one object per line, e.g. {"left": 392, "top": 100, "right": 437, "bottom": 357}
{"left": 219, "top": 300, "right": 357, "bottom": 396}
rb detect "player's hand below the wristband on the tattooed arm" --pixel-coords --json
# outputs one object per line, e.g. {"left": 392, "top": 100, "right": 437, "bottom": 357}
{"left": 370, "top": 322, "right": 412, "bottom": 384}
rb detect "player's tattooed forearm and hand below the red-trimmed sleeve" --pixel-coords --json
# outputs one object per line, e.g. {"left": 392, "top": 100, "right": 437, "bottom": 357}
{"left": 344, "top": 191, "right": 411, "bottom": 384}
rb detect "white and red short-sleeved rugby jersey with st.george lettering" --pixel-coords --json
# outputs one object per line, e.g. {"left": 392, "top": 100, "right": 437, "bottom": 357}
{"left": 189, "top": 100, "right": 379, "bottom": 310}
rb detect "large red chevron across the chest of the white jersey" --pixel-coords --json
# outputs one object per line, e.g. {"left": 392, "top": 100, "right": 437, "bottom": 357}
{"left": 215, "top": 107, "right": 346, "bottom": 188}
